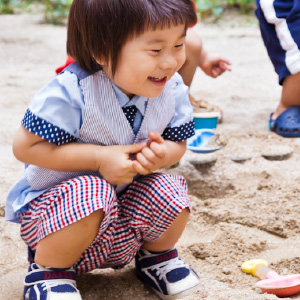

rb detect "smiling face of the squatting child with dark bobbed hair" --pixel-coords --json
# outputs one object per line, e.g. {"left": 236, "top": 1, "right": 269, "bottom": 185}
{"left": 100, "top": 25, "right": 186, "bottom": 98}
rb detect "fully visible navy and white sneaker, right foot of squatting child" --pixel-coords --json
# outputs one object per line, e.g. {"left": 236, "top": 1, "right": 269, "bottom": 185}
{"left": 135, "top": 248, "right": 200, "bottom": 300}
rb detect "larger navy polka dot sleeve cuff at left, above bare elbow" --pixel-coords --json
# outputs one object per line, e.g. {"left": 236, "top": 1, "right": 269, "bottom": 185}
{"left": 22, "top": 109, "right": 76, "bottom": 146}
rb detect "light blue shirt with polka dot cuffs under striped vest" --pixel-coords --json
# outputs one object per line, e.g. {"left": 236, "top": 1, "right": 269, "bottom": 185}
{"left": 6, "top": 65, "right": 194, "bottom": 222}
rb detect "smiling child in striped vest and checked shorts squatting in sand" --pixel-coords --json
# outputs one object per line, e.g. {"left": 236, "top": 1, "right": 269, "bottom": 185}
{"left": 6, "top": 0, "right": 200, "bottom": 300}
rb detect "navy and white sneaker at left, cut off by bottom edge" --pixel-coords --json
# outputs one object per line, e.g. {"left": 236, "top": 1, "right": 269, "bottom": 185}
{"left": 23, "top": 263, "right": 82, "bottom": 300}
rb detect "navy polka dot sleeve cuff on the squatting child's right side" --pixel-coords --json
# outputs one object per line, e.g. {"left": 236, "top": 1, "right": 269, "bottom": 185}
{"left": 162, "top": 121, "right": 195, "bottom": 142}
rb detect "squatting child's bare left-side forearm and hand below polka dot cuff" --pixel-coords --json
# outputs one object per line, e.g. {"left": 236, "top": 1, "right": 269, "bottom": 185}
{"left": 13, "top": 126, "right": 146, "bottom": 185}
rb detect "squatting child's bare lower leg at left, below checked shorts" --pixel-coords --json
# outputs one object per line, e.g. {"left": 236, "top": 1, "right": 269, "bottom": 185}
{"left": 35, "top": 209, "right": 104, "bottom": 268}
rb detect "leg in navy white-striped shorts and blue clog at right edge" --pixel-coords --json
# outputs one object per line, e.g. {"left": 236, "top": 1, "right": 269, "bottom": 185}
{"left": 255, "top": 0, "right": 300, "bottom": 137}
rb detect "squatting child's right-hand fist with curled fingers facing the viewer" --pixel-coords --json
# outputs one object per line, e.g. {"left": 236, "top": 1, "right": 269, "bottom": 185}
{"left": 133, "top": 131, "right": 167, "bottom": 175}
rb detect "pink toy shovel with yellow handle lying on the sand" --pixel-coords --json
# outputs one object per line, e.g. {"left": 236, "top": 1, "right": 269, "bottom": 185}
{"left": 242, "top": 259, "right": 300, "bottom": 297}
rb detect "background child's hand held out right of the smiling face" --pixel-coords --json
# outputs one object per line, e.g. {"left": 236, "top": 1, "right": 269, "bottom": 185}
{"left": 199, "top": 53, "right": 231, "bottom": 78}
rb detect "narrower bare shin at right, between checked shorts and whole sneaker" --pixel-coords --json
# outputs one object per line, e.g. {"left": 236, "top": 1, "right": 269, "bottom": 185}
{"left": 143, "top": 208, "right": 190, "bottom": 252}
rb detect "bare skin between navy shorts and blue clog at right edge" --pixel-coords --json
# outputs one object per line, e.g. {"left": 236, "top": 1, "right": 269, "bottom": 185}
{"left": 272, "top": 72, "right": 300, "bottom": 120}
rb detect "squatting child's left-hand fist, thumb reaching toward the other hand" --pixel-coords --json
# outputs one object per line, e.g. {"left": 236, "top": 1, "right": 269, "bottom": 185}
{"left": 96, "top": 143, "right": 146, "bottom": 185}
